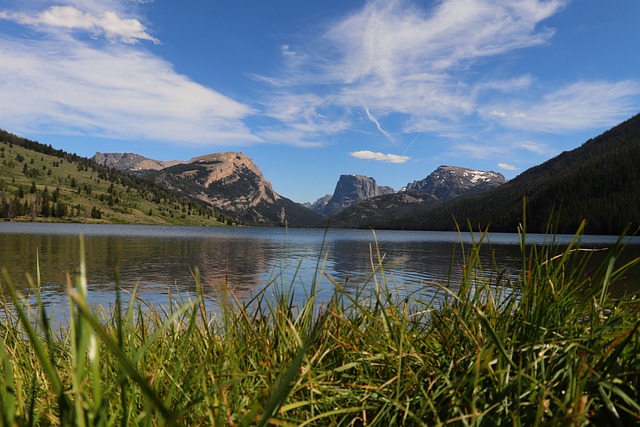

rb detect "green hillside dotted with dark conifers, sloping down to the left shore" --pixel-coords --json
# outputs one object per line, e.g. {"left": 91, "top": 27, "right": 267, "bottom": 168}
{"left": 0, "top": 131, "right": 233, "bottom": 225}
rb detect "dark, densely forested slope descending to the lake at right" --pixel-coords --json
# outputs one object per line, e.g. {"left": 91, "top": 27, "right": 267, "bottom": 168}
{"left": 396, "top": 115, "right": 640, "bottom": 234}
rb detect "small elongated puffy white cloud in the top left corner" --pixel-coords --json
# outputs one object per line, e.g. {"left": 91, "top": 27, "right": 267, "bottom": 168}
{"left": 0, "top": 6, "right": 159, "bottom": 43}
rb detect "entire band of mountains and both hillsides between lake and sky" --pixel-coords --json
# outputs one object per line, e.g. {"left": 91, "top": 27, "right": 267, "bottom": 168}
{"left": 0, "top": 115, "right": 640, "bottom": 234}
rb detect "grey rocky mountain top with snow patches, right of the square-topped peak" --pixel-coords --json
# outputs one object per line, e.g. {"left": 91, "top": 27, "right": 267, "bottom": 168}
{"left": 403, "top": 166, "right": 506, "bottom": 201}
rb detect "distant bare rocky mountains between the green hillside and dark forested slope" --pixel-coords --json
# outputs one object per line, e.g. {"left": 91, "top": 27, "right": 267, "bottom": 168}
{"left": 92, "top": 152, "right": 505, "bottom": 227}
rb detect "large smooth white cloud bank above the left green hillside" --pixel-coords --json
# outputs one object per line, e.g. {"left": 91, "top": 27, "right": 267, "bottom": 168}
{"left": 0, "top": 37, "right": 260, "bottom": 145}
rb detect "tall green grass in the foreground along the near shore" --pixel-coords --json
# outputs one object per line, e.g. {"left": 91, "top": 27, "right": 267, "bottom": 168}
{"left": 0, "top": 226, "right": 640, "bottom": 426}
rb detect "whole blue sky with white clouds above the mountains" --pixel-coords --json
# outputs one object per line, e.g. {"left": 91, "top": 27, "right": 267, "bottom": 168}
{"left": 0, "top": 0, "right": 640, "bottom": 202}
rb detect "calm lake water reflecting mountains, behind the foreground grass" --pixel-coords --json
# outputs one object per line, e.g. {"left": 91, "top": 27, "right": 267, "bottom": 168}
{"left": 0, "top": 223, "right": 640, "bottom": 318}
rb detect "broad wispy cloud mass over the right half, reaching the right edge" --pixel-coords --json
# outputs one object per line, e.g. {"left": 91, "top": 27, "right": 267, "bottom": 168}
{"left": 263, "top": 0, "right": 638, "bottom": 150}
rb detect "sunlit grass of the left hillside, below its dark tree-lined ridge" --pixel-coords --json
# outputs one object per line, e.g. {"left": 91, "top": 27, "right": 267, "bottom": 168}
{"left": 0, "top": 141, "right": 223, "bottom": 225}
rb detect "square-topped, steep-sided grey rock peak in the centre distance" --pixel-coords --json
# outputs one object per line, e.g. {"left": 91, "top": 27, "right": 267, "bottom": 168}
{"left": 322, "top": 175, "right": 395, "bottom": 216}
